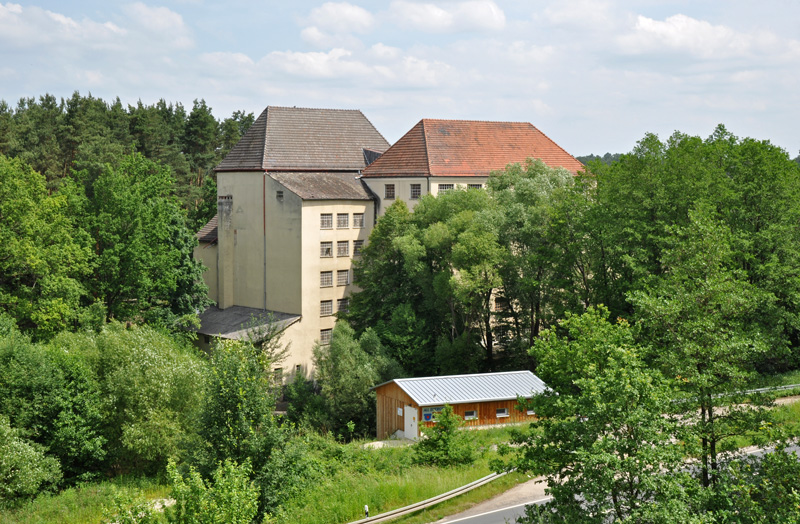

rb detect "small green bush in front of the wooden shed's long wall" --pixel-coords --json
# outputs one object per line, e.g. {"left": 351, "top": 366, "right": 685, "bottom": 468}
{"left": 414, "top": 404, "right": 475, "bottom": 467}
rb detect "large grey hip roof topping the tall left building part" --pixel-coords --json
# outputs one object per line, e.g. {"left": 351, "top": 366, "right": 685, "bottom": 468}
{"left": 216, "top": 107, "right": 389, "bottom": 171}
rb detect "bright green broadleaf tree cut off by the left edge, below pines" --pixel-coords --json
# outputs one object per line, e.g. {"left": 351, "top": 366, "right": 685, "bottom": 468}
{"left": 0, "top": 155, "right": 90, "bottom": 338}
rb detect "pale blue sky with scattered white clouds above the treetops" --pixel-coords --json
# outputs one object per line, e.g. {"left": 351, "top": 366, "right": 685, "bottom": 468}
{"left": 0, "top": 0, "right": 800, "bottom": 157}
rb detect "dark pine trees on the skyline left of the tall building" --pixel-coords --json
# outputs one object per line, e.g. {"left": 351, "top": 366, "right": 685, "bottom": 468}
{"left": 0, "top": 92, "right": 254, "bottom": 230}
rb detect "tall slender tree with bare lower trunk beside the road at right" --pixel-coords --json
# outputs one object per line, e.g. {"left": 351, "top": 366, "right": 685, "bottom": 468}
{"left": 630, "top": 207, "right": 772, "bottom": 486}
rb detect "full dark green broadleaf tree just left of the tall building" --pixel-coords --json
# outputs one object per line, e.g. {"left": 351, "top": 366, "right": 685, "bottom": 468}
{"left": 78, "top": 154, "right": 208, "bottom": 329}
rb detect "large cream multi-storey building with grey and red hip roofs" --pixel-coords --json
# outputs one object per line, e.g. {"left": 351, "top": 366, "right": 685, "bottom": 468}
{"left": 195, "top": 107, "right": 582, "bottom": 376}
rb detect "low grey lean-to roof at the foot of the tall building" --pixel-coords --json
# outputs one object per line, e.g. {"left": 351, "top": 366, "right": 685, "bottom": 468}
{"left": 197, "top": 306, "right": 300, "bottom": 339}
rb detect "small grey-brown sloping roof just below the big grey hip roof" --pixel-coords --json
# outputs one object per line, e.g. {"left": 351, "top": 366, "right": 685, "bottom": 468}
{"left": 270, "top": 172, "right": 372, "bottom": 200}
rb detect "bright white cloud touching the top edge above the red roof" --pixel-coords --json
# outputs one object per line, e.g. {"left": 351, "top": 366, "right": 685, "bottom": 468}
{"left": 390, "top": 0, "right": 506, "bottom": 33}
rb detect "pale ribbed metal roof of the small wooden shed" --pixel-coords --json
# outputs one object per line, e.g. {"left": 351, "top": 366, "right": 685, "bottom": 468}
{"left": 373, "top": 371, "right": 549, "bottom": 406}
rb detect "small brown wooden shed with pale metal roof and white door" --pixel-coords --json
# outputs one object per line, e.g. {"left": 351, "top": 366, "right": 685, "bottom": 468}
{"left": 372, "top": 371, "right": 547, "bottom": 439}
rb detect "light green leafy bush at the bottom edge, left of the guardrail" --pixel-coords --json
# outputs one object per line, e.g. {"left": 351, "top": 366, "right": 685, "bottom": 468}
{"left": 167, "top": 459, "right": 258, "bottom": 524}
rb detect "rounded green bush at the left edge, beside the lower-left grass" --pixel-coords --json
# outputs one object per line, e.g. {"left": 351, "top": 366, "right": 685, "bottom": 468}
{"left": 0, "top": 416, "right": 61, "bottom": 508}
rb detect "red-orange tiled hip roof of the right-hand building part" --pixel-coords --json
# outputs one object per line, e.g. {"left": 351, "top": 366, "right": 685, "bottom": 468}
{"left": 363, "top": 119, "right": 583, "bottom": 178}
